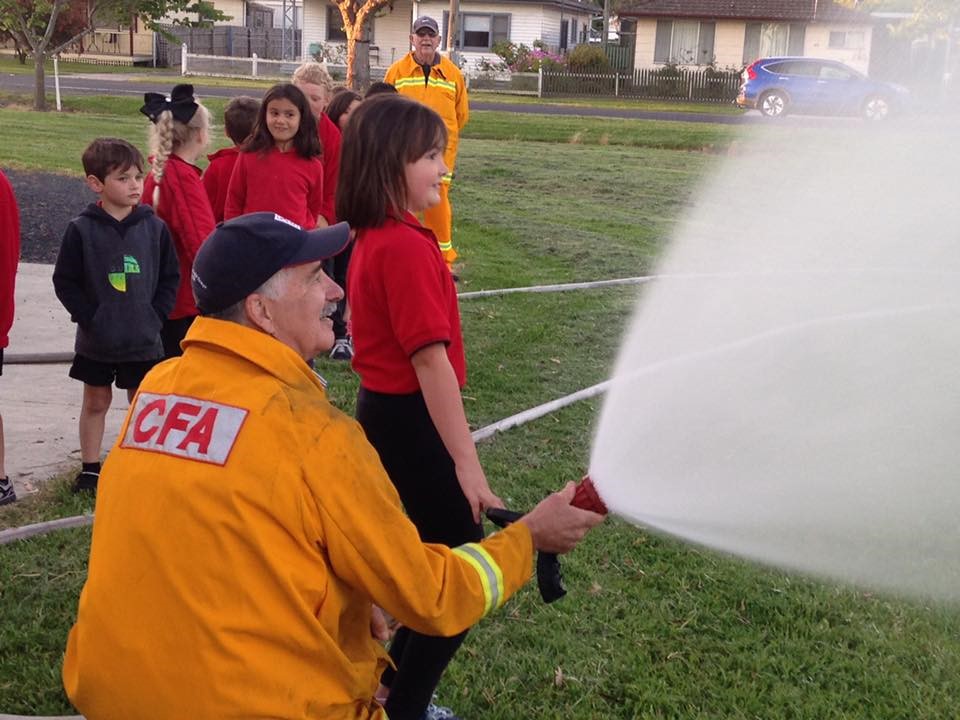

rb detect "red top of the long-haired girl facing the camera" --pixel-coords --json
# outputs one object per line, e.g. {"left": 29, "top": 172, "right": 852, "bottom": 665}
{"left": 223, "top": 147, "right": 323, "bottom": 230}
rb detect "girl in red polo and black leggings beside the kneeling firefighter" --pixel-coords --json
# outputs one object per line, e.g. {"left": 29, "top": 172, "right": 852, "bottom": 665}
{"left": 336, "top": 95, "right": 502, "bottom": 720}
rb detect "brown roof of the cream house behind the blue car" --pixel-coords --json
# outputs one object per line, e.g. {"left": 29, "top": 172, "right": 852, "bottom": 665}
{"left": 618, "top": 0, "right": 870, "bottom": 23}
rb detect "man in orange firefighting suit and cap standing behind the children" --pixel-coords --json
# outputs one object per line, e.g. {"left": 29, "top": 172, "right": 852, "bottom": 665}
{"left": 384, "top": 15, "right": 470, "bottom": 267}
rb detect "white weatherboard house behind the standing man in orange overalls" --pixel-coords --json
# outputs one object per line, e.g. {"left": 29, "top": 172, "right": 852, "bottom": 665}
{"left": 303, "top": 0, "right": 597, "bottom": 72}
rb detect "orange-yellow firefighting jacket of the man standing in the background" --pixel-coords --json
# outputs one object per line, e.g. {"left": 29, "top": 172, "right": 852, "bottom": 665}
{"left": 383, "top": 52, "right": 470, "bottom": 175}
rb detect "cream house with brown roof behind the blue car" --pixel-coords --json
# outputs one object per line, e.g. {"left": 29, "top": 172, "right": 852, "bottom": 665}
{"left": 619, "top": 0, "right": 873, "bottom": 73}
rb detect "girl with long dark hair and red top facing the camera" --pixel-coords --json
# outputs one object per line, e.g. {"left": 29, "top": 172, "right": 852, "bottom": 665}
{"left": 223, "top": 83, "right": 327, "bottom": 230}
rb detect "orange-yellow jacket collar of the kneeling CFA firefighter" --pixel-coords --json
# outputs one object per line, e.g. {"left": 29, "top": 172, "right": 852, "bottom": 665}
{"left": 183, "top": 317, "right": 327, "bottom": 396}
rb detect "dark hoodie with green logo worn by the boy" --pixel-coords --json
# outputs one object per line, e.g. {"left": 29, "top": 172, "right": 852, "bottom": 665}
{"left": 53, "top": 204, "right": 180, "bottom": 362}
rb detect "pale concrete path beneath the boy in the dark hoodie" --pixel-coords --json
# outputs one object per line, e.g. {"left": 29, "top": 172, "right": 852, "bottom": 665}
{"left": 0, "top": 263, "right": 127, "bottom": 496}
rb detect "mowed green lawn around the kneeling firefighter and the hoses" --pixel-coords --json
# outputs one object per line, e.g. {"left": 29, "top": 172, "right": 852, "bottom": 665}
{"left": 0, "top": 102, "right": 960, "bottom": 720}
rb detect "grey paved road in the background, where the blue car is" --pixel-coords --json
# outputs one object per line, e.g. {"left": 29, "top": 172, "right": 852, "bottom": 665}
{"left": 0, "top": 74, "right": 764, "bottom": 125}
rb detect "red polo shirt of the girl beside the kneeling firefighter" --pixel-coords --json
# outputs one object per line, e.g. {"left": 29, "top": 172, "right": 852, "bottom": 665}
{"left": 347, "top": 213, "right": 467, "bottom": 395}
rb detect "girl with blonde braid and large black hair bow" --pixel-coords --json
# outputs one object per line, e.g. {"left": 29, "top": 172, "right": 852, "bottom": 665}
{"left": 140, "top": 85, "right": 216, "bottom": 358}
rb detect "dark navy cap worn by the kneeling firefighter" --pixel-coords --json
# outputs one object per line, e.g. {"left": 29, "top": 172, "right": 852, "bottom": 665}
{"left": 190, "top": 212, "right": 350, "bottom": 315}
